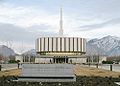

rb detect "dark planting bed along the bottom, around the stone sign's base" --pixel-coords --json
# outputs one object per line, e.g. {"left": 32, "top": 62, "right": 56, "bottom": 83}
{"left": 0, "top": 76, "right": 120, "bottom": 86}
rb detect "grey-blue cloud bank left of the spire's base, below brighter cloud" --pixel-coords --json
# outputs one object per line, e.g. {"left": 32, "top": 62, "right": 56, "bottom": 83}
{"left": 0, "top": 23, "right": 56, "bottom": 42}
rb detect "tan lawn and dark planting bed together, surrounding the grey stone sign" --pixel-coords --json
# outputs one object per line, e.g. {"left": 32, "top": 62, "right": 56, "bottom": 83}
{"left": 0, "top": 65, "right": 120, "bottom": 86}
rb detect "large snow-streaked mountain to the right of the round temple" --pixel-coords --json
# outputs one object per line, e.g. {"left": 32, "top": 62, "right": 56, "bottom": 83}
{"left": 87, "top": 35, "right": 120, "bottom": 56}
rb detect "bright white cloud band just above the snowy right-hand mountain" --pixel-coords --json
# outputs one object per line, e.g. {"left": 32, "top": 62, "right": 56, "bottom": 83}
{"left": 71, "top": 24, "right": 120, "bottom": 39}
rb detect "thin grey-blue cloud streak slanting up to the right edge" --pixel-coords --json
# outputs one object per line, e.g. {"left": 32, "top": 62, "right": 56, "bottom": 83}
{"left": 79, "top": 18, "right": 120, "bottom": 31}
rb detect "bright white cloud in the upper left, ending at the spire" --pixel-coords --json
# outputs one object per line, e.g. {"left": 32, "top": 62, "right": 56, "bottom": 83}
{"left": 0, "top": 4, "right": 59, "bottom": 28}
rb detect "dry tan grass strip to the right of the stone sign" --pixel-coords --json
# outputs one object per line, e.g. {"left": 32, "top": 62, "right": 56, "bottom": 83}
{"left": 74, "top": 65, "right": 120, "bottom": 77}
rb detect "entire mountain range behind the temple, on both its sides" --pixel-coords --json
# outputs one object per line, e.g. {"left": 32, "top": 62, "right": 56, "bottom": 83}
{"left": 0, "top": 35, "right": 120, "bottom": 57}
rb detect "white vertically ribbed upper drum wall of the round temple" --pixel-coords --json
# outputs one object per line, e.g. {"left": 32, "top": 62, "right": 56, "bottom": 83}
{"left": 36, "top": 37, "right": 86, "bottom": 52}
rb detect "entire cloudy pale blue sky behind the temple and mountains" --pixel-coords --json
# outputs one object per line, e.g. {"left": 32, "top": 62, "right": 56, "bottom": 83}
{"left": 0, "top": 0, "right": 120, "bottom": 53}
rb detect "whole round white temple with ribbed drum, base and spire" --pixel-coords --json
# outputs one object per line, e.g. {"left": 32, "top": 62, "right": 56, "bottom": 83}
{"left": 35, "top": 8, "right": 87, "bottom": 63}
